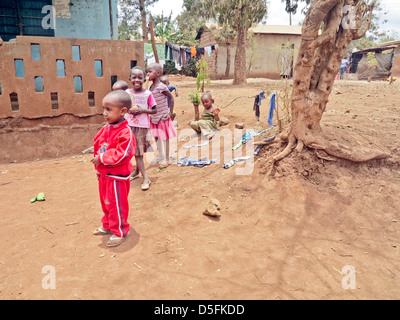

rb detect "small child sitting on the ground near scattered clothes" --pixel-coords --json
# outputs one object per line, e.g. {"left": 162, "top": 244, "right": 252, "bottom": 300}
{"left": 189, "top": 92, "right": 220, "bottom": 139}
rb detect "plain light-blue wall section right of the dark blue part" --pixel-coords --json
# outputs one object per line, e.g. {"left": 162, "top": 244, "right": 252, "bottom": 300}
{"left": 53, "top": 0, "right": 118, "bottom": 40}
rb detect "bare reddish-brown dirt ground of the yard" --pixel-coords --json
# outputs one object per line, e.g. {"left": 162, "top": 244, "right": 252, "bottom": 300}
{"left": 0, "top": 76, "right": 400, "bottom": 300}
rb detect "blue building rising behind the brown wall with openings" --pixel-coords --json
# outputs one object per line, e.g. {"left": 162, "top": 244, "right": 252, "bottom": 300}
{"left": 0, "top": 0, "right": 118, "bottom": 41}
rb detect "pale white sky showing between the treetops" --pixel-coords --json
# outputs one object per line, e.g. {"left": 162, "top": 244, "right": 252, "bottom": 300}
{"left": 150, "top": 0, "right": 400, "bottom": 37}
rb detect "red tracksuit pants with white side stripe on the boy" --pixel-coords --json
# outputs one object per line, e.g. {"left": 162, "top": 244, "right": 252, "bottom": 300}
{"left": 99, "top": 174, "right": 130, "bottom": 237}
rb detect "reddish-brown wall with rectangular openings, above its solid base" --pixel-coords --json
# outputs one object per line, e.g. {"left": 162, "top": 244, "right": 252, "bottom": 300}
{"left": 0, "top": 36, "right": 144, "bottom": 119}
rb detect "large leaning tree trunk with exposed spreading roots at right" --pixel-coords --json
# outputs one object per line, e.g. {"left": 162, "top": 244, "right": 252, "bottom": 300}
{"left": 273, "top": 0, "right": 389, "bottom": 162}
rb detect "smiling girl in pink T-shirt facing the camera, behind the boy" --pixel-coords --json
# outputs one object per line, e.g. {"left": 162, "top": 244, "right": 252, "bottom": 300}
{"left": 126, "top": 67, "right": 157, "bottom": 190}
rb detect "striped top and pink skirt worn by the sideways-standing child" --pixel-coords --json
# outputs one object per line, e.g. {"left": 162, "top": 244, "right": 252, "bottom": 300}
{"left": 150, "top": 82, "right": 176, "bottom": 140}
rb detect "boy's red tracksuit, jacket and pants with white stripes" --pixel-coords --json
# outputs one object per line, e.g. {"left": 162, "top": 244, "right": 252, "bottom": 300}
{"left": 94, "top": 120, "right": 136, "bottom": 237}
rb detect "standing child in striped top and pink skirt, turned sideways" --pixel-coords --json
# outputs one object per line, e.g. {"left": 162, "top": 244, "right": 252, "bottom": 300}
{"left": 147, "top": 63, "right": 176, "bottom": 167}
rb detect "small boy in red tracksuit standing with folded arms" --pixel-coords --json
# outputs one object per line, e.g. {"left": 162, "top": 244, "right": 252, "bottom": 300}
{"left": 91, "top": 90, "right": 136, "bottom": 247}
